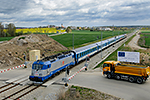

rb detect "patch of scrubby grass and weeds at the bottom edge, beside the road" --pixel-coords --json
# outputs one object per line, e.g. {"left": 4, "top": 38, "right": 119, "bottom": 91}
{"left": 58, "top": 85, "right": 121, "bottom": 100}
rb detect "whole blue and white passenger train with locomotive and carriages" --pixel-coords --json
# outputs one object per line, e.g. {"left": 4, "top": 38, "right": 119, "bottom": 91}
{"left": 29, "top": 34, "right": 127, "bottom": 82}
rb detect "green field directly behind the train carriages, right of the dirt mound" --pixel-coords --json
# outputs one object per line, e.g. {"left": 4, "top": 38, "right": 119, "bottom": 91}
{"left": 51, "top": 30, "right": 130, "bottom": 48}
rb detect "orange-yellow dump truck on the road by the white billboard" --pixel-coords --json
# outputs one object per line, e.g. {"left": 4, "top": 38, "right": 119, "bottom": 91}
{"left": 103, "top": 61, "right": 150, "bottom": 84}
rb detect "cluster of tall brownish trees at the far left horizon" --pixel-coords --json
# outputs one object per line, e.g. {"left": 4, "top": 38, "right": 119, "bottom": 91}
{"left": 0, "top": 22, "right": 16, "bottom": 37}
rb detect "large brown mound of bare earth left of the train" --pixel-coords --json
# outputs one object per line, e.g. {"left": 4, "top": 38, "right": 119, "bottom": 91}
{"left": 0, "top": 34, "right": 68, "bottom": 68}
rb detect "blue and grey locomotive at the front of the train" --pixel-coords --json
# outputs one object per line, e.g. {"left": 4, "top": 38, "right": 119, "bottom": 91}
{"left": 29, "top": 51, "right": 75, "bottom": 82}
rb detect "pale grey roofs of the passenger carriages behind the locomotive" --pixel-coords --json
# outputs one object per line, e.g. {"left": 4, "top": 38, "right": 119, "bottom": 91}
{"left": 73, "top": 35, "right": 124, "bottom": 53}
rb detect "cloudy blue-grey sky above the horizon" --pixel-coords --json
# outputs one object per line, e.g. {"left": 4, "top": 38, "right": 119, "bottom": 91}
{"left": 0, "top": 0, "right": 150, "bottom": 27}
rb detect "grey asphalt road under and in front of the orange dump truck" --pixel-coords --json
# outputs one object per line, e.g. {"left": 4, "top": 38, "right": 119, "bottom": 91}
{"left": 69, "top": 71, "right": 150, "bottom": 100}
